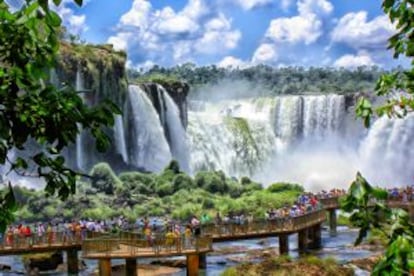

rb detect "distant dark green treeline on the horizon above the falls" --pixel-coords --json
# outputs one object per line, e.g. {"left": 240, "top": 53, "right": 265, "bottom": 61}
{"left": 128, "top": 63, "right": 394, "bottom": 95}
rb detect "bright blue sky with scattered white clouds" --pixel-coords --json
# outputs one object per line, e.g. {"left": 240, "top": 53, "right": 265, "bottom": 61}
{"left": 51, "top": 0, "right": 408, "bottom": 69}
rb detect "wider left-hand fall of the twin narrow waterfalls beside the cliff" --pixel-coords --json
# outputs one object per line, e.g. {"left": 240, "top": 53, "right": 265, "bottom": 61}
{"left": 128, "top": 85, "right": 171, "bottom": 171}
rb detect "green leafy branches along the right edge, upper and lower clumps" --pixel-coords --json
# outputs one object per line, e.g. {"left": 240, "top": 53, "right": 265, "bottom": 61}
{"left": 342, "top": 0, "right": 414, "bottom": 275}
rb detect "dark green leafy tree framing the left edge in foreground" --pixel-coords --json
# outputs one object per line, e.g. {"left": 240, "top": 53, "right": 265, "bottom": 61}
{"left": 0, "top": 0, "right": 120, "bottom": 233}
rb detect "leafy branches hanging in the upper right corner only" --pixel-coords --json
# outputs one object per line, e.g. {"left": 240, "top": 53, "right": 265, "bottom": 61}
{"left": 356, "top": 0, "right": 414, "bottom": 126}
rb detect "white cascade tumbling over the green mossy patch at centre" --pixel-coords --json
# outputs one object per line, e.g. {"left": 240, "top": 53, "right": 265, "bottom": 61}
{"left": 187, "top": 99, "right": 276, "bottom": 176}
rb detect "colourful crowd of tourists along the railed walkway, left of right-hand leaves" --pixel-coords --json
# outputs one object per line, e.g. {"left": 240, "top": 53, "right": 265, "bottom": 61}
{"left": 2, "top": 189, "right": 368, "bottom": 250}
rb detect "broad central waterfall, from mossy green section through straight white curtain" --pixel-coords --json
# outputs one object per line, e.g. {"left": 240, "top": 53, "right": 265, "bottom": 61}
{"left": 188, "top": 95, "right": 353, "bottom": 188}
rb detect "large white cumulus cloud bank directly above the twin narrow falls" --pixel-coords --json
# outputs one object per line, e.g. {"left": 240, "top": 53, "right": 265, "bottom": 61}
{"left": 108, "top": 0, "right": 241, "bottom": 64}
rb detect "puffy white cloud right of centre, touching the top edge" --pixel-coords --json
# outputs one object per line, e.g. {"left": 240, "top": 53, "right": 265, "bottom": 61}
{"left": 265, "top": 0, "right": 333, "bottom": 45}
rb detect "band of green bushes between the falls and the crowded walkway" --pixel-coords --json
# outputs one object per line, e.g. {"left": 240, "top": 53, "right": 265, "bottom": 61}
{"left": 8, "top": 161, "right": 303, "bottom": 222}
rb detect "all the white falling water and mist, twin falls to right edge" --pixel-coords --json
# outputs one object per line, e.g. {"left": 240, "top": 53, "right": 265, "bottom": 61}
{"left": 63, "top": 81, "right": 414, "bottom": 190}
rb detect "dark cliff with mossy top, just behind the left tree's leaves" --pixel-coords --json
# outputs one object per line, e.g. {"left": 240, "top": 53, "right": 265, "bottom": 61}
{"left": 56, "top": 42, "right": 128, "bottom": 171}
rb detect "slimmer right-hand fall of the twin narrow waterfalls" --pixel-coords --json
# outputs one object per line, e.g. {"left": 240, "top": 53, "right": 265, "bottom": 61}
{"left": 157, "top": 85, "right": 190, "bottom": 172}
